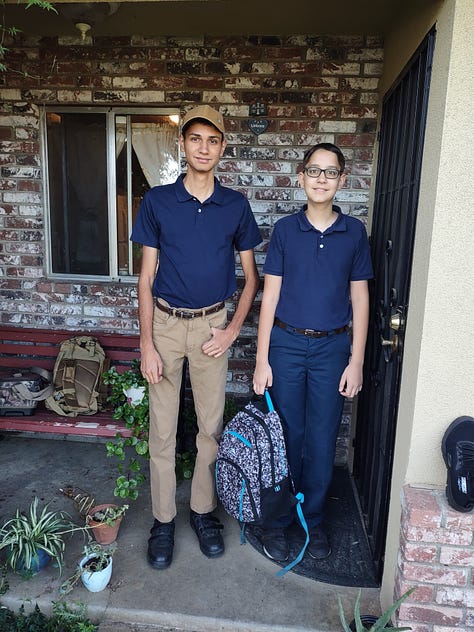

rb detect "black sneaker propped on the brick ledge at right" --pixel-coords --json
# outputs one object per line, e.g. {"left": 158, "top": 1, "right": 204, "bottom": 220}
{"left": 441, "top": 417, "right": 474, "bottom": 512}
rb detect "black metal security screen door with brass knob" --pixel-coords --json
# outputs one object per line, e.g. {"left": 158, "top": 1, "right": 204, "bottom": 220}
{"left": 354, "top": 29, "right": 435, "bottom": 578}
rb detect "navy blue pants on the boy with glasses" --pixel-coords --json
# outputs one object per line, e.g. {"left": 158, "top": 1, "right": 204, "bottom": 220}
{"left": 268, "top": 326, "right": 351, "bottom": 528}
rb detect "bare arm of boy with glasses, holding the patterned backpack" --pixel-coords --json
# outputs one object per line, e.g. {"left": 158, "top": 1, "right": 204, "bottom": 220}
{"left": 253, "top": 274, "right": 282, "bottom": 395}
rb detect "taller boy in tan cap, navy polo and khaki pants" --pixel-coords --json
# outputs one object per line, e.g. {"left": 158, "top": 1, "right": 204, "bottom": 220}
{"left": 131, "top": 105, "right": 261, "bottom": 569}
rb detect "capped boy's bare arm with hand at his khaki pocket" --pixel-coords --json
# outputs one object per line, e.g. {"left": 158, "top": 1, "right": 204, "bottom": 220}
{"left": 202, "top": 250, "right": 260, "bottom": 358}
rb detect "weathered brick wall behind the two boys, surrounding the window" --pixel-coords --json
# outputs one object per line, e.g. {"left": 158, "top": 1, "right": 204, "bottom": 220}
{"left": 0, "top": 35, "right": 382, "bottom": 404}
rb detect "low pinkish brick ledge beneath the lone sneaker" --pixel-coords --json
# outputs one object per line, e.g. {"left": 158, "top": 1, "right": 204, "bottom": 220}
{"left": 396, "top": 485, "right": 474, "bottom": 632}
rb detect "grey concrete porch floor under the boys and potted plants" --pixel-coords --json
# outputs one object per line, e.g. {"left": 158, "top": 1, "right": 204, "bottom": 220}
{"left": 0, "top": 433, "right": 380, "bottom": 632}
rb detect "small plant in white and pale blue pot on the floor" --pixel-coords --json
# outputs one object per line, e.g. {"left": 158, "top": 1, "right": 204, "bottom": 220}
{"left": 59, "top": 542, "right": 117, "bottom": 595}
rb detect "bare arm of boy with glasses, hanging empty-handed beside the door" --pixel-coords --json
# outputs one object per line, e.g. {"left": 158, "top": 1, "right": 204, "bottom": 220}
{"left": 339, "top": 281, "right": 369, "bottom": 397}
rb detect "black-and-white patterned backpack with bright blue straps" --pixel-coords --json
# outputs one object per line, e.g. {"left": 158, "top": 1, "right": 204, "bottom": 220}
{"left": 215, "top": 391, "right": 309, "bottom": 575}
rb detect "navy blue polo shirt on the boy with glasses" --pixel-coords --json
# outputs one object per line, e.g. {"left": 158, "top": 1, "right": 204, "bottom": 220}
{"left": 263, "top": 206, "right": 373, "bottom": 331}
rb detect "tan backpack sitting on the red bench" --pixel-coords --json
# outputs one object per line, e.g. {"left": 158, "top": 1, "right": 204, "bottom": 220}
{"left": 45, "top": 336, "right": 107, "bottom": 417}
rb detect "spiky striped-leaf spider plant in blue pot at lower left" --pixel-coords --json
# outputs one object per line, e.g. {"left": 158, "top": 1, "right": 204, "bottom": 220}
{"left": 0, "top": 497, "right": 86, "bottom": 577}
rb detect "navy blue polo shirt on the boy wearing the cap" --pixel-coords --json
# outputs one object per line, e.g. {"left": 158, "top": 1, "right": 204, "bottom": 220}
{"left": 130, "top": 175, "right": 262, "bottom": 309}
